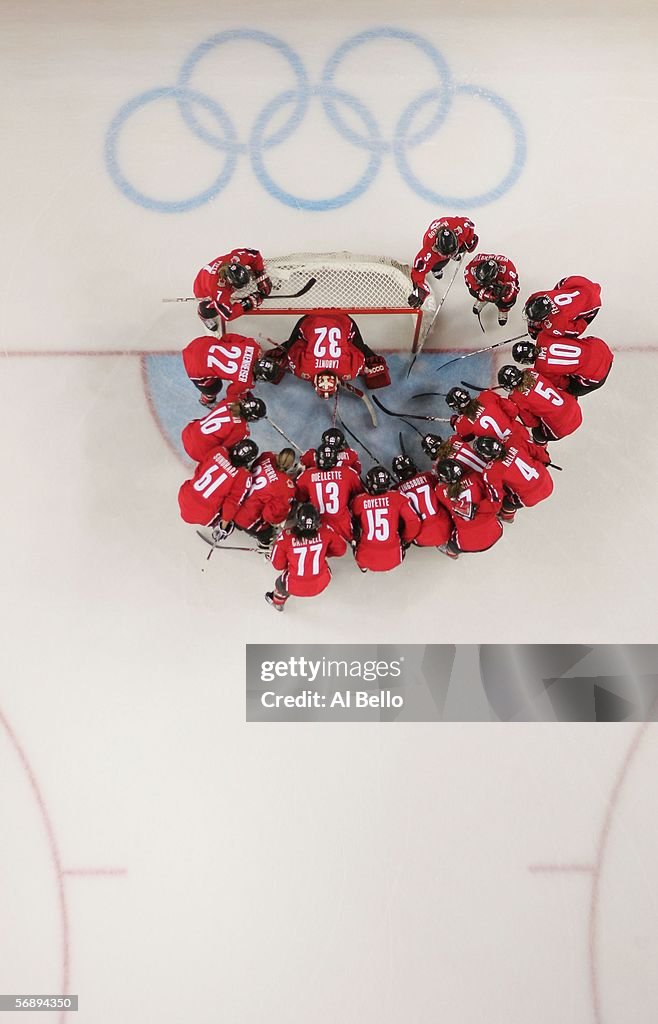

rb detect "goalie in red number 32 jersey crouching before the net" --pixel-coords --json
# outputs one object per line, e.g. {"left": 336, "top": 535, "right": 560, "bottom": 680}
{"left": 268, "top": 311, "right": 391, "bottom": 398}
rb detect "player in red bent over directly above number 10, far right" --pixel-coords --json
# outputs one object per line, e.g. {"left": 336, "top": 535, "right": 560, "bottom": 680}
{"left": 523, "top": 275, "right": 601, "bottom": 338}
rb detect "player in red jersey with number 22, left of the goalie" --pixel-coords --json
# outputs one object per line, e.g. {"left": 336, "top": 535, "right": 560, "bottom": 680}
{"left": 182, "top": 334, "right": 274, "bottom": 408}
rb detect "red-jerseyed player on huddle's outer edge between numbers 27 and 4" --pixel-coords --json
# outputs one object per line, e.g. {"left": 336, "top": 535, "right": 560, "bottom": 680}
{"left": 435, "top": 459, "right": 502, "bottom": 558}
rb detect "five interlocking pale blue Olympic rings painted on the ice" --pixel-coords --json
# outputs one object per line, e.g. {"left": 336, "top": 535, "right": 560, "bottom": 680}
{"left": 105, "top": 28, "right": 526, "bottom": 213}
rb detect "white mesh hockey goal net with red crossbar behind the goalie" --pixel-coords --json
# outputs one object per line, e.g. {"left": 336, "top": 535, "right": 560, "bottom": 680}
{"left": 224, "top": 252, "right": 436, "bottom": 351}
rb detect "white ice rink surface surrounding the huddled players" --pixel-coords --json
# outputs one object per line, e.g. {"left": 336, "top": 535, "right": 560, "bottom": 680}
{"left": 0, "top": 0, "right": 658, "bottom": 1024}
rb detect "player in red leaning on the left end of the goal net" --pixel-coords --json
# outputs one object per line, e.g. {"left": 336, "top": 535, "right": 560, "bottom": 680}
{"left": 192, "top": 249, "right": 272, "bottom": 331}
